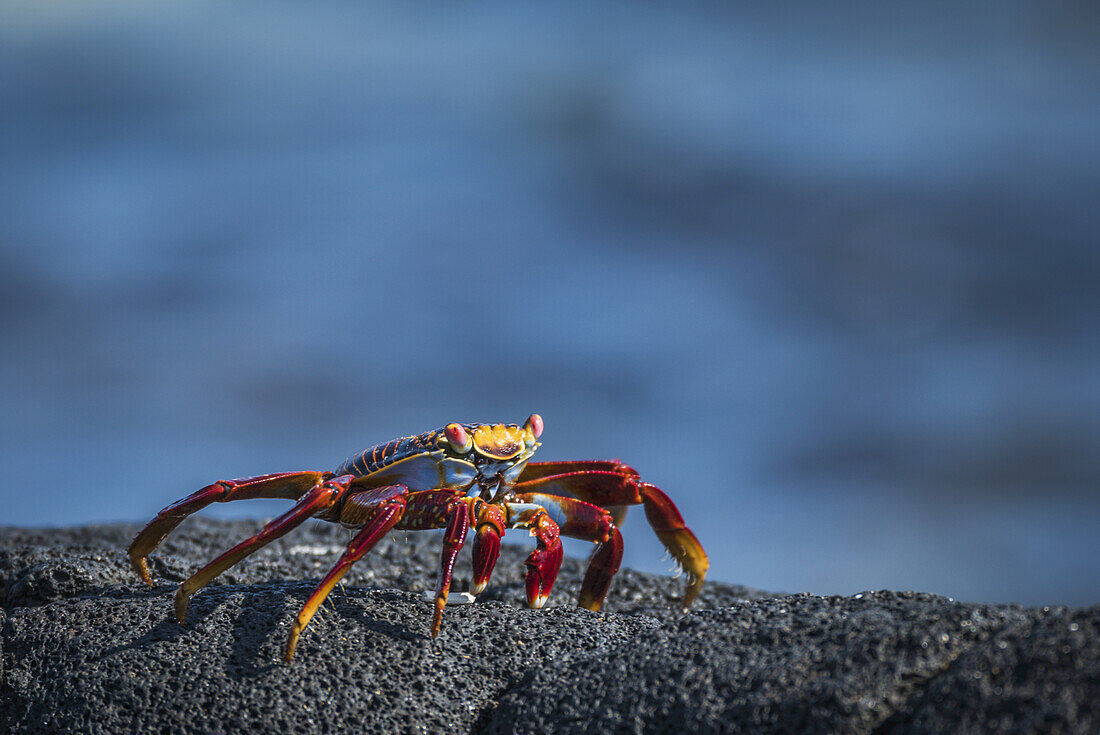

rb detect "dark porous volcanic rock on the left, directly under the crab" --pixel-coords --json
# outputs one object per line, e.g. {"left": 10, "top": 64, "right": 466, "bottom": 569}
{"left": 0, "top": 518, "right": 761, "bottom": 733}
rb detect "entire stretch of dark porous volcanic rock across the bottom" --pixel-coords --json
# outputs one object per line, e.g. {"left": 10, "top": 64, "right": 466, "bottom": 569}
{"left": 0, "top": 518, "right": 1100, "bottom": 734}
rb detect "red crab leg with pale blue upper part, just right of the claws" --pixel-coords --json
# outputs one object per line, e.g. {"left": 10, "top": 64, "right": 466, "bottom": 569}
{"left": 516, "top": 493, "right": 623, "bottom": 611}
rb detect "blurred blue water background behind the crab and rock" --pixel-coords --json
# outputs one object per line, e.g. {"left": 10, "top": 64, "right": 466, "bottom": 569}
{"left": 0, "top": 0, "right": 1100, "bottom": 604}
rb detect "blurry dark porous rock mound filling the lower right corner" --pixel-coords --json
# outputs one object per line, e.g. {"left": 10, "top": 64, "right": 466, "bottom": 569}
{"left": 487, "top": 592, "right": 1100, "bottom": 733}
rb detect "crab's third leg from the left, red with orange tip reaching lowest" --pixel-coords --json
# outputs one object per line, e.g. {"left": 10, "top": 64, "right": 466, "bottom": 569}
{"left": 284, "top": 485, "right": 408, "bottom": 661}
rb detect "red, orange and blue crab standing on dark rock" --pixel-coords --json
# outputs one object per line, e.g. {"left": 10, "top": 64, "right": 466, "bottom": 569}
{"left": 129, "top": 414, "right": 708, "bottom": 662}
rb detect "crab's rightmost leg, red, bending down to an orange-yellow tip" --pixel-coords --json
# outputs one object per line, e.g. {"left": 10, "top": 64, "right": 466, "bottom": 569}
{"left": 515, "top": 462, "right": 710, "bottom": 608}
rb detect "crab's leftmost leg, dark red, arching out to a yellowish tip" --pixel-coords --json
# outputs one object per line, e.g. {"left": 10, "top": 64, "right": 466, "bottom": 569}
{"left": 129, "top": 472, "right": 332, "bottom": 586}
